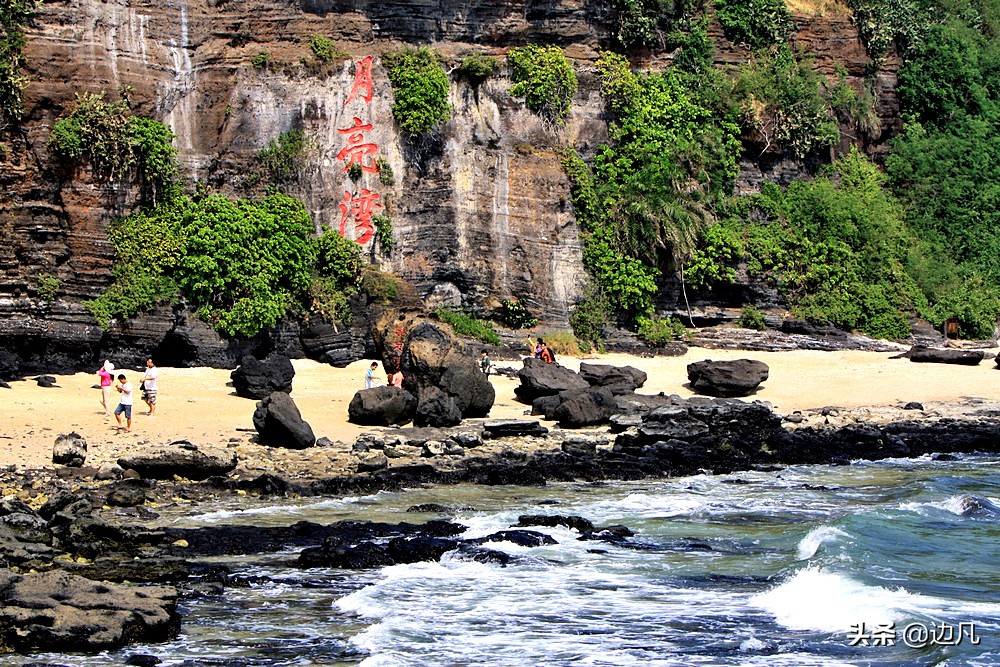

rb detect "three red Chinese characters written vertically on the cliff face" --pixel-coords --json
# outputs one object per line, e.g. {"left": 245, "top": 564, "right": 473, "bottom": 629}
{"left": 337, "top": 56, "right": 382, "bottom": 245}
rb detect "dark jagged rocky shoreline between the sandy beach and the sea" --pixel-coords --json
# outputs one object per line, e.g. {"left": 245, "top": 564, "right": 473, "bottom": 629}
{"left": 0, "top": 386, "right": 1000, "bottom": 652}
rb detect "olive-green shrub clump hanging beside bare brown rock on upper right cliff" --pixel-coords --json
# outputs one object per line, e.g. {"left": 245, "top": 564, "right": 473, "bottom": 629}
{"left": 735, "top": 47, "right": 840, "bottom": 157}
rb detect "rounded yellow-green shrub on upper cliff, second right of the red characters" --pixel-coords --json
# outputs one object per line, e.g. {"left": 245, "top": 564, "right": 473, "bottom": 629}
{"left": 507, "top": 44, "right": 577, "bottom": 125}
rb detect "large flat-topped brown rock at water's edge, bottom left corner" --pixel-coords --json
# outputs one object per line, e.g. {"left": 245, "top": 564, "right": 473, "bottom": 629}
{"left": 0, "top": 569, "right": 180, "bottom": 653}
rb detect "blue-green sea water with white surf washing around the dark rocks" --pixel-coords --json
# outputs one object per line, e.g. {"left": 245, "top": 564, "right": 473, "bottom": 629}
{"left": 0, "top": 456, "right": 1000, "bottom": 667}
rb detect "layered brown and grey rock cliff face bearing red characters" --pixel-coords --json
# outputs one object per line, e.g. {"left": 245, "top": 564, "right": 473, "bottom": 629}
{"left": 0, "top": 0, "right": 896, "bottom": 374}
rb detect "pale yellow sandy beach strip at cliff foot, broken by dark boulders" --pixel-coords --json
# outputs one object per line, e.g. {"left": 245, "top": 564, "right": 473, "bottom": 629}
{"left": 0, "top": 348, "right": 1000, "bottom": 467}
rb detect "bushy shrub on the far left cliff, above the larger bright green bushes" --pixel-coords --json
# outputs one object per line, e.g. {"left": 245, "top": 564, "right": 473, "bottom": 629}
{"left": 49, "top": 93, "right": 177, "bottom": 205}
